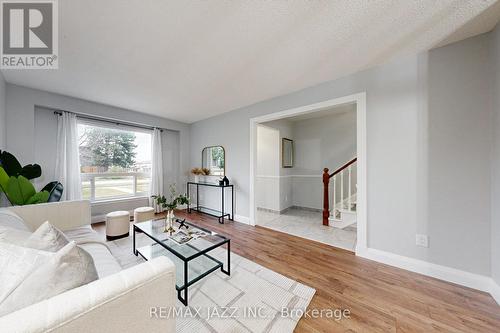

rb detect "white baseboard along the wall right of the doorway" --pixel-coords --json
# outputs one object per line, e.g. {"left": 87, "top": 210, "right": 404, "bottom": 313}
{"left": 356, "top": 248, "right": 500, "bottom": 304}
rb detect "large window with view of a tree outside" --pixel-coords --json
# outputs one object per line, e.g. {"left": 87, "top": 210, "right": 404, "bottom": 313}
{"left": 78, "top": 121, "right": 151, "bottom": 201}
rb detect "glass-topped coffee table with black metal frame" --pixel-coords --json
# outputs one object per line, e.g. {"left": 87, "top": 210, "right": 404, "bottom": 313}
{"left": 133, "top": 220, "right": 231, "bottom": 306}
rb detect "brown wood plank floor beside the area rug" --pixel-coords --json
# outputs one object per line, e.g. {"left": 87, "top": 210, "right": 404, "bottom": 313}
{"left": 96, "top": 211, "right": 500, "bottom": 332}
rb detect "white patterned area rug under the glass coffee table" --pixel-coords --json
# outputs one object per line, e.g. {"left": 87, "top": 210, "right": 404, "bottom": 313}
{"left": 107, "top": 230, "right": 316, "bottom": 333}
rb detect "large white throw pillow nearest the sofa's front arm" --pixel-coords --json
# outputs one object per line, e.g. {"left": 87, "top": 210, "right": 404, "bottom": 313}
{"left": 0, "top": 242, "right": 97, "bottom": 316}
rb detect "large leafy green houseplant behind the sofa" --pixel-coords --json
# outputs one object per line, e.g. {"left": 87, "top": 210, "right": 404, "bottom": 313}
{"left": 0, "top": 150, "right": 63, "bottom": 206}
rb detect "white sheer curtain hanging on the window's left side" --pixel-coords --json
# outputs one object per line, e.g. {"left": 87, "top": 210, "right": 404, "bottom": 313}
{"left": 56, "top": 112, "right": 82, "bottom": 200}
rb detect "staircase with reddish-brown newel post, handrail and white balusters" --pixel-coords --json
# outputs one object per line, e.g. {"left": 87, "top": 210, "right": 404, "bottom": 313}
{"left": 323, "top": 158, "right": 357, "bottom": 229}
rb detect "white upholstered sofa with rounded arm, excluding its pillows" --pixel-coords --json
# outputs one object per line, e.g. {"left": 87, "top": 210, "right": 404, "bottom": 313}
{"left": 0, "top": 200, "right": 177, "bottom": 333}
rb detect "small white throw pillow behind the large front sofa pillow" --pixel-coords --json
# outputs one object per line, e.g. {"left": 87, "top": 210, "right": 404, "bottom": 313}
{"left": 24, "top": 221, "right": 69, "bottom": 252}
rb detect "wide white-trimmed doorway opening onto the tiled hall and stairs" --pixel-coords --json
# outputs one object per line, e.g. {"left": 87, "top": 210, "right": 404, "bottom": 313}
{"left": 250, "top": 93, "right": 366, "bottom": 252}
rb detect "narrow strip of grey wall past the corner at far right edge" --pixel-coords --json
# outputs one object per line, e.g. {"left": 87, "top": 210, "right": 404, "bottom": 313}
{"left": 491, "top": 25, "right": 500, "bottom": 285}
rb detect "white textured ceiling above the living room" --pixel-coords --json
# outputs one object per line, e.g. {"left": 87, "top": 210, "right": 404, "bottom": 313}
{"left": 3, "top": 0, "right": 498, "bottom": 122}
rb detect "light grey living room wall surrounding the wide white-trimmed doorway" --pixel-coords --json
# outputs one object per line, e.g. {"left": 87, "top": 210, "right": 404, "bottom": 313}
{"left": 191, "top": 31, "right": 490, "bottom": 275}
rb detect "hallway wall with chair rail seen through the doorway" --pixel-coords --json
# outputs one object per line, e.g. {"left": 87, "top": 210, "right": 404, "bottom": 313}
{"left": 256, "top": 109, "right": 356, "bottom": 210}
